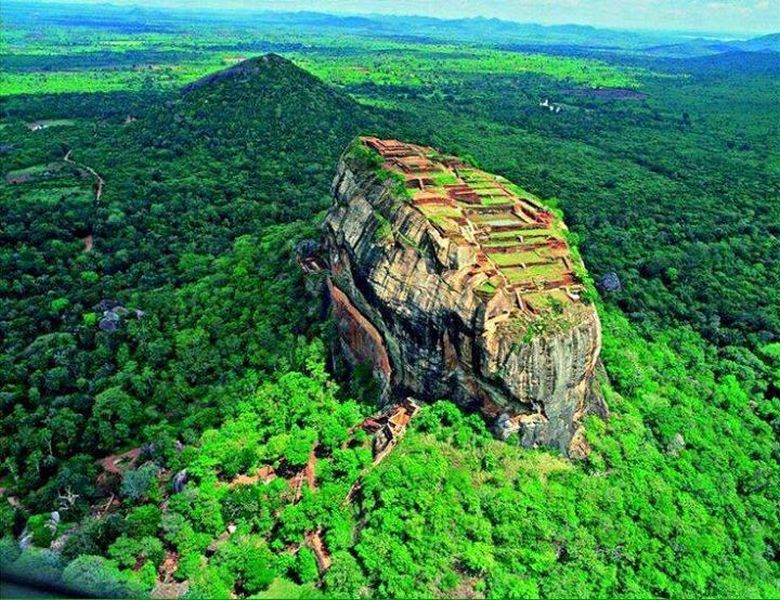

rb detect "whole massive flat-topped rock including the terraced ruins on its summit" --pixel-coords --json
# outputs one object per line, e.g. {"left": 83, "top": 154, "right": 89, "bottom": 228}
{"left": 324, "top": 138, "right": 607, "bottom": 457}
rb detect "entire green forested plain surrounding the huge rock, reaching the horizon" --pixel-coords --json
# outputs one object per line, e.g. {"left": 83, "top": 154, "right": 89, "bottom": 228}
{"left": 0, "top": 3, "right": 780, "bottom": 598}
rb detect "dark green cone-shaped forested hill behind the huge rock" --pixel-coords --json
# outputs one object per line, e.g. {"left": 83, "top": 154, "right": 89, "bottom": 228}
{"left": 123, "top": 54, "right": 372, "bottom": 233}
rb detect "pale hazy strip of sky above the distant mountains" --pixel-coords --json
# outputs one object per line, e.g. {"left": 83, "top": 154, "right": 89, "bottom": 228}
{"left": 32, "top": 0, "right": 780, "bottom": 33}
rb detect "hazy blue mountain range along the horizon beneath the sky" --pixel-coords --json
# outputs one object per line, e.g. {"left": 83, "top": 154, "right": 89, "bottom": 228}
{"left": 7, "top": 0, "right": 780, "bottom": 58}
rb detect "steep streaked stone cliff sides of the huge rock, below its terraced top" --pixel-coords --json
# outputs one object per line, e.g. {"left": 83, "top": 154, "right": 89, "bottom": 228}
{"left": 323, "top": 138, "right": 607, "bottom": 456}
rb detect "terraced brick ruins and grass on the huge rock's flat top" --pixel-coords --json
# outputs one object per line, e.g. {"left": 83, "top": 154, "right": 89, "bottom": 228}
{"left": 362, "top": 137, "right": 582, "bottom": 318}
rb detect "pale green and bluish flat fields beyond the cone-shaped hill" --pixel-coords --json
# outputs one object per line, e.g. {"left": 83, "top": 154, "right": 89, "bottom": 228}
{"left": 0, "top": 4, "right": 650, "bottom": 99}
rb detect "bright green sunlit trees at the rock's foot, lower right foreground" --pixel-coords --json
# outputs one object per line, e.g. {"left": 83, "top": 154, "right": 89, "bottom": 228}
{"left": 350, "top": 310, "right": 777, "bottom": 597}
